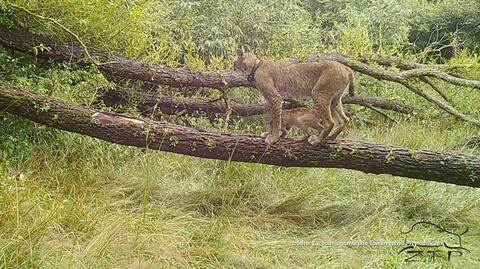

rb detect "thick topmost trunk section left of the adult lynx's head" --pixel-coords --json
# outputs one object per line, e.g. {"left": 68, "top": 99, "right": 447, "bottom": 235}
{"left": 0, "top": 26, "right": 255, "bottom": 89}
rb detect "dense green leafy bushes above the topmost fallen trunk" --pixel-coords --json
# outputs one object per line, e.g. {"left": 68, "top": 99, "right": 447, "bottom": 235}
{"left": 0, "top": 0, "right": 480, "bottom": 68}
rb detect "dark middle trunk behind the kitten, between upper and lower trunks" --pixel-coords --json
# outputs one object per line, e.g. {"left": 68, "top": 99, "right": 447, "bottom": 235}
{"left": 99, "top": 87, "right": 420, "bottom": 117}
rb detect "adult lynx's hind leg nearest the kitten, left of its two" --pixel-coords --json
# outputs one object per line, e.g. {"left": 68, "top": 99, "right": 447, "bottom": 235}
{"left": 308, "top": 94, "right": 334, "bottom": 146}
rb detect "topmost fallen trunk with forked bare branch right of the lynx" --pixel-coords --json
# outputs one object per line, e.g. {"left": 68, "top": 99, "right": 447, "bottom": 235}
{"left": 0, "top": 27, "right": 480, "bottom": 125}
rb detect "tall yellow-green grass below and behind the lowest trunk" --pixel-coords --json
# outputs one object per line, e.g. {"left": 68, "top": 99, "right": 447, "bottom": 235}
{"left": 0, "top": 116, "right": 480, "bottom": 268}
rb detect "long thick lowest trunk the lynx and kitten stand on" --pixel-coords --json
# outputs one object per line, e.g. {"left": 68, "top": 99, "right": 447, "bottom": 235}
{"left": 0, "top": 85, "right": 480, "bottom": 187}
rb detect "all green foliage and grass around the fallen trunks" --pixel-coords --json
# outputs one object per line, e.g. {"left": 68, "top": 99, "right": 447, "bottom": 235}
{"left": 0, "top": 0, "right": 480, "bottom": 268}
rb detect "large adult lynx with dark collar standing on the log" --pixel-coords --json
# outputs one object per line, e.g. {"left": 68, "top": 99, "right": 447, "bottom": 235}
{"left": 234, "top": 53, "right": 354, "bottom": 145}
